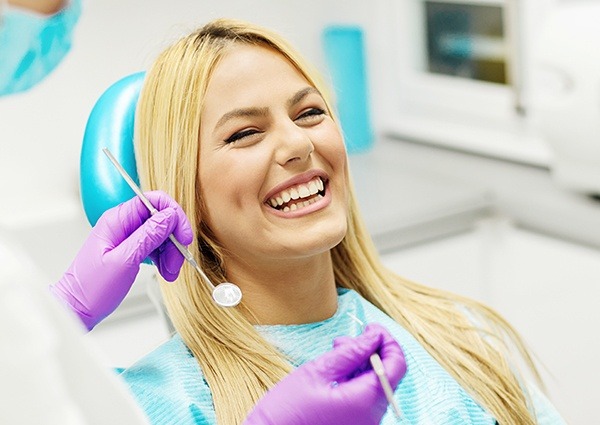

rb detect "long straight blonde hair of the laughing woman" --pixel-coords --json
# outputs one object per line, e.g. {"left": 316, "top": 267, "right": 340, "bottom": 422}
{"left": 136, "top": 19, "right": 539, "bottom": 424}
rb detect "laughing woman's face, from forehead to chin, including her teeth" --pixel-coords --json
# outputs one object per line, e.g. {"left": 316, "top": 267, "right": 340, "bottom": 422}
{"left": 198, "top": 44, "right": 348, "bottom": 268}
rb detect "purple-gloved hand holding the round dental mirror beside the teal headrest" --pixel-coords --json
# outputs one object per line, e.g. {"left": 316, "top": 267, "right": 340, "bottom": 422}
{"left": 50, "top": 191, "right": 193, "bottom": 330}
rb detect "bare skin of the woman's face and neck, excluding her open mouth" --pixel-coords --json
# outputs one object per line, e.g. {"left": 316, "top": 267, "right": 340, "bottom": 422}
{"left": 198, "top": 45, "right": 348, "bottom": 324}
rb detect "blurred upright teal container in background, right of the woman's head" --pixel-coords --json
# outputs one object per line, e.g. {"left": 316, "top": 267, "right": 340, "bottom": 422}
{"left": 323, "top": 25, "right": 374, "bottom": 154}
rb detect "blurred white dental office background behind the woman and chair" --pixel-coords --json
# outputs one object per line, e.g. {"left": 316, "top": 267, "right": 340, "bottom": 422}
{"left": 0, "top": 0, "right": 600, "bottom": 424}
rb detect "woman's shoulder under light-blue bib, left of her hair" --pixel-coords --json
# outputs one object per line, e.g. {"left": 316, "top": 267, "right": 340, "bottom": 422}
{"left": 121, "top": 335, "right": 214, "bottom": 424}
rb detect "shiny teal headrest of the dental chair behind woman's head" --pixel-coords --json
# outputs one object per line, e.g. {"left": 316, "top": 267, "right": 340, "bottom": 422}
{"left": 79, "top": 72, "right": 145, "bottom": 226}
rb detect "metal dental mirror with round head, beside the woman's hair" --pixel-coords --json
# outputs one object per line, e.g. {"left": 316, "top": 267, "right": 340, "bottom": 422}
{"left": 102, "top": 148, "right": 243, "bottom": 306}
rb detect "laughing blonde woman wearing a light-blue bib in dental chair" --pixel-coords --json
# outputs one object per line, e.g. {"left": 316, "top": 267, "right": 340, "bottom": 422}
{"left": 123, "top": 20, "right": 562, "bottom": 425}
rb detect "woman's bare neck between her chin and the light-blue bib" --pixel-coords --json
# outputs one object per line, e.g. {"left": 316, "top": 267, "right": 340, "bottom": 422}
{"left": 227, "top": 252, "right": 337, "bottom": 325}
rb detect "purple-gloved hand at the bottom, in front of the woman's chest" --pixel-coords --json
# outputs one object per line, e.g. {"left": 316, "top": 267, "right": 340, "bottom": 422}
{"left": 243, "top": 324, "right": 406, "bottom": 425}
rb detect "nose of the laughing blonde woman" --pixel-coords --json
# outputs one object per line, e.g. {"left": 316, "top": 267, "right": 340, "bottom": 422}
{"left": 275, "top": 120, "right": 315, "bottom": 166}
